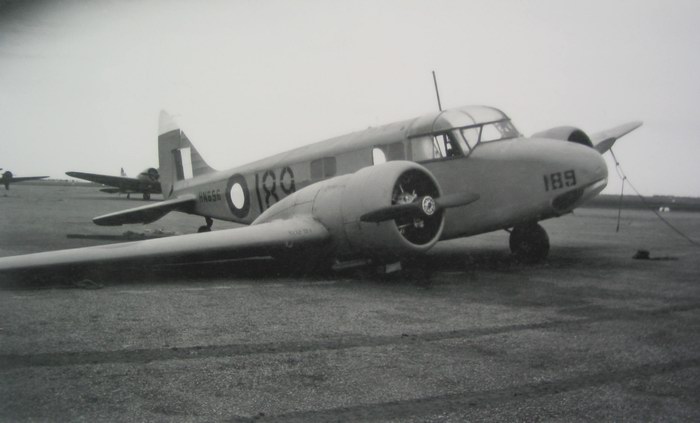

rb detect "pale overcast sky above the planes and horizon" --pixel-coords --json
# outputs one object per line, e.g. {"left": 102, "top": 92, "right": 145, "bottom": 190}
{"left": 0, "top": 0, "right": 700, "bottom": 196}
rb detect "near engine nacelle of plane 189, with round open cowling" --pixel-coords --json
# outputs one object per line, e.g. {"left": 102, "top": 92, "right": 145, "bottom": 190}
{"left": 253, "top": 161, "right": 444, "bottom": 259}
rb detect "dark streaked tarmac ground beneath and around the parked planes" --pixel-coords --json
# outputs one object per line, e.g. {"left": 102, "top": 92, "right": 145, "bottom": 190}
{"left": 0, "top": 184, "right": 700, "bottom": 422}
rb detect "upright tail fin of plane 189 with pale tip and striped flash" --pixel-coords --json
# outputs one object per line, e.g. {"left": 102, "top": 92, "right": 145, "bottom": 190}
{"left": 158, "top": 111, "right": 216, "bottom": 199}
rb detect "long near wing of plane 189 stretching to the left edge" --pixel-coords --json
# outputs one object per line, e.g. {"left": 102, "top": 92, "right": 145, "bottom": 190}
{"left": 0, "top": 217, "right": 330, "bottom": 272}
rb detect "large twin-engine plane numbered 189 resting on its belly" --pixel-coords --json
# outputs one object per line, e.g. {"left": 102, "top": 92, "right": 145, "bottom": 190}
{"left": 0, "top": 106, "right": 641, "bottom": 270}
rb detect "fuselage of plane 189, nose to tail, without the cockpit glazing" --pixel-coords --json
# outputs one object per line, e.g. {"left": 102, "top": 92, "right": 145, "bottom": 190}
{"left": 165, "top": 107, "right": 607, "bottom": 239}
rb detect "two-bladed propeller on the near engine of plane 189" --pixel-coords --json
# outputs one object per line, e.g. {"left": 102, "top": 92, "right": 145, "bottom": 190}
{"left": 360, "top": 192, "right": 480, "bottom": 223}
